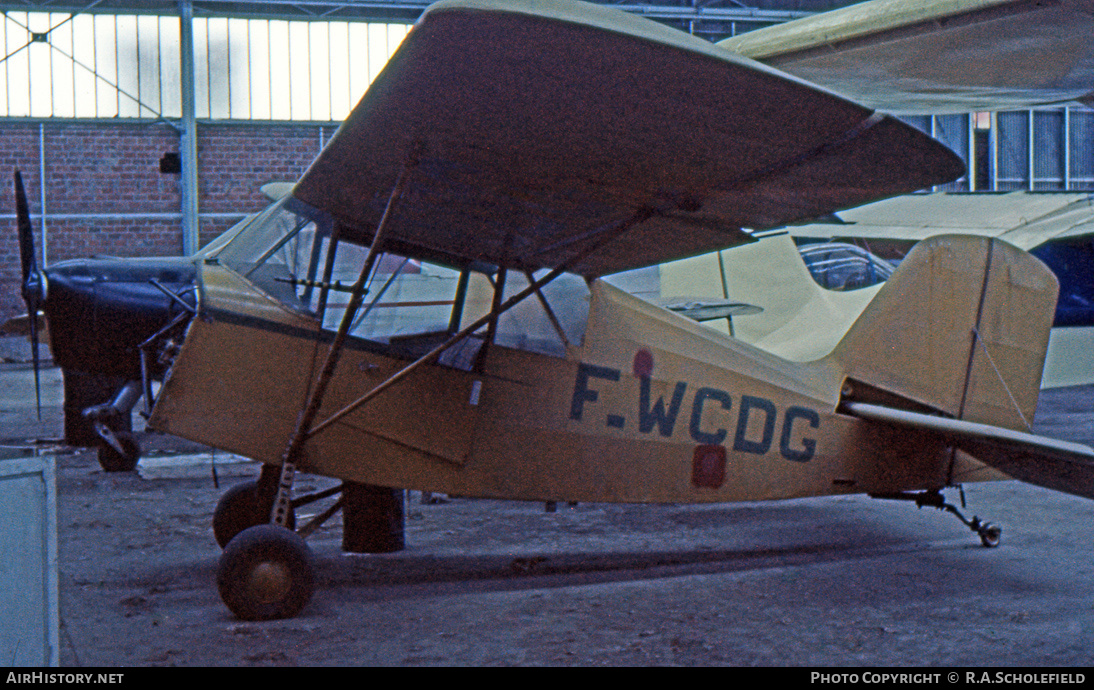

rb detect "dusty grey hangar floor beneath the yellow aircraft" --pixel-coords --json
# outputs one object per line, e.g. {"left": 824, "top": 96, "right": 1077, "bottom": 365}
{"left": 6, "top": 336, "right": 1094, "bottom": 667}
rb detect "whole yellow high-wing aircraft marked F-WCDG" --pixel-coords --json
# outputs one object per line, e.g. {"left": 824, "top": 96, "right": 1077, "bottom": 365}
{"left": 12, "top": 0, "right": 1094, "bottom": 619}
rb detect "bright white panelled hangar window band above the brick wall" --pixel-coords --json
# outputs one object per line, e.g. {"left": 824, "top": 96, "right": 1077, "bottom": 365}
{"left": 0, "top": 11, "right": 410, "bottom": 121}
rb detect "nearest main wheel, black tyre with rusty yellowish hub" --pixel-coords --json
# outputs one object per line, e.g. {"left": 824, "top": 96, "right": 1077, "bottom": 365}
{"left": 217, "top": 525, "right": 315, "bottom": 620}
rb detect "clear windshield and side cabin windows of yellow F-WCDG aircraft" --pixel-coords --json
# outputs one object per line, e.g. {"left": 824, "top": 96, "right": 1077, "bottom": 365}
{"left": 207, "top": 198, "right": 589, "bottom": 365}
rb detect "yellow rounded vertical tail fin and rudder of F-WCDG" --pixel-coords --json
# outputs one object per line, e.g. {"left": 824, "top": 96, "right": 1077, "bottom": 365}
{"left": 830, "top": 235, "right": 1058, "bottom": 431}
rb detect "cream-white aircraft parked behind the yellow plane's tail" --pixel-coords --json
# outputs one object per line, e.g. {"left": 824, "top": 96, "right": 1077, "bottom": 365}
{"left": 661, "top": 191, "right": 1094, "bottom": 388}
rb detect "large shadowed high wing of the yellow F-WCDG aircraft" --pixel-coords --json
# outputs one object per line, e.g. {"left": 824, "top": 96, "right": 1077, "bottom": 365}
{"left": 293, "top": 0, "right": 963, "bottom": 277}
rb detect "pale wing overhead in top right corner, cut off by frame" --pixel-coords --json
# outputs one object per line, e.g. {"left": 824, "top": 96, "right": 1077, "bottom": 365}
{"left": 719, "top": 0, "right": 1094, "bottom": 114}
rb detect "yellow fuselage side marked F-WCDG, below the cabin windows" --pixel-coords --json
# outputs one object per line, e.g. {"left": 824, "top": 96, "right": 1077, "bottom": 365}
{"left": 150, "top": 261, "right": 993, "bottom": 502}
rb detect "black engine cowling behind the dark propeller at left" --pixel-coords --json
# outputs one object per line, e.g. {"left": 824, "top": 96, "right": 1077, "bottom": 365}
{"left": 42, "top": 257, "right": 197, "bottom": 381}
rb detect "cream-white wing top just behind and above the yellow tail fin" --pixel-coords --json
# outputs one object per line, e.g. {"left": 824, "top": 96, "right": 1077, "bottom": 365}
{"left": 789, "top": 191, "right": 1094, "bottom": 252}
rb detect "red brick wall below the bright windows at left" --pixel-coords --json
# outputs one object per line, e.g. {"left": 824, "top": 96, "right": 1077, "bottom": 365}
{"left": 0, "top": 121, "right": 335, "bottom": 320}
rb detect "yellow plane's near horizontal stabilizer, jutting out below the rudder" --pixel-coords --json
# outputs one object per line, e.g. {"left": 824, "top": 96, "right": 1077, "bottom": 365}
{"left": 842, "top": 402, "right": 1094, "bottom": 499}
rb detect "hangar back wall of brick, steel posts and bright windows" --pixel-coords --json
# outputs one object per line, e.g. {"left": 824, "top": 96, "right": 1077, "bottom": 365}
{"left": 0, "top": 0, "right": 1094, "bottom": 317}
